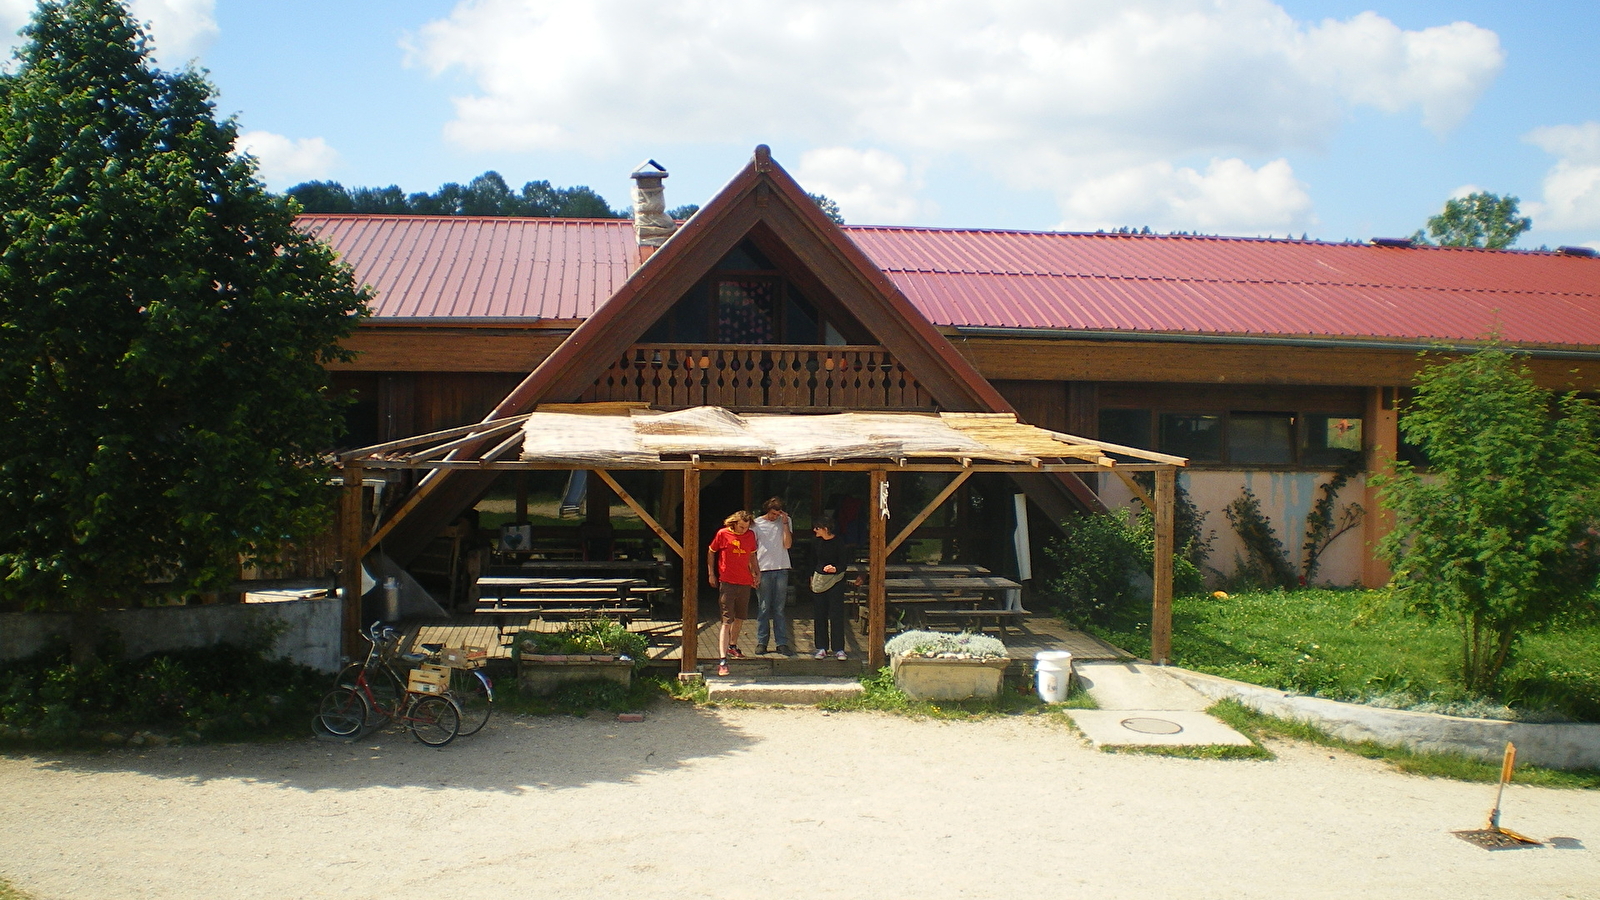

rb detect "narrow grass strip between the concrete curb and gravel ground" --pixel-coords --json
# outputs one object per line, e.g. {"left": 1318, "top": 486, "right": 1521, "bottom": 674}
{"left": 1206, "top": 700, "right": 1600, "bottom": 790}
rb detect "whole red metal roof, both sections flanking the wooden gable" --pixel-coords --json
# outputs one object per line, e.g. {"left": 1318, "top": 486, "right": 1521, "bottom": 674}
{"left": 301, "top": 216, "right": 1600, "bottom": 346}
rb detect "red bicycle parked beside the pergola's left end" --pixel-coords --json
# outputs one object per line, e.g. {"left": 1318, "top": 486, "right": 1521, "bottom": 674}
{"left": 317, "top": 621, "right": 460, "bottom": 746}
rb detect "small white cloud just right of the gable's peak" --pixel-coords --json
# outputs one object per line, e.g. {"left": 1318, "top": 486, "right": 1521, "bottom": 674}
{"left": 795, "top": 147, "right": 938, "bottom": 224}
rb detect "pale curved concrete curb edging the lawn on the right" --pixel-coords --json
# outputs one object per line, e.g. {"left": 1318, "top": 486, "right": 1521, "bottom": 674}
{"left": 1166, "top": 666, "right": 1600, "bottom": 769}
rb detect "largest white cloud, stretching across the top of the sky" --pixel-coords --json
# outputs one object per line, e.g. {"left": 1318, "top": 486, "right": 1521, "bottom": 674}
{"left": 408, "top": 0, "right": 1504, "bottom": 235}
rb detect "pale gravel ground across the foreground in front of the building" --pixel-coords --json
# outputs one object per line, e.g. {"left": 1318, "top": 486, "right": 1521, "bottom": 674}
{"left": 0, "top": 706, "right": 1600, "bottom": 900}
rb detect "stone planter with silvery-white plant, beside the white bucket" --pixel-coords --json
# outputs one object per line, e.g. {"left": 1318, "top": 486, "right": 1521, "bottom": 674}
{"left": 883, "top": 631, "right": 1011, "bottom": 700}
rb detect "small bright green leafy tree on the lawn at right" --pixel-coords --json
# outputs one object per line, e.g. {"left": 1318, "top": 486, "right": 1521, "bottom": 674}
{"left": 1378, "top": 346, "right": 1600, "bottom": 692}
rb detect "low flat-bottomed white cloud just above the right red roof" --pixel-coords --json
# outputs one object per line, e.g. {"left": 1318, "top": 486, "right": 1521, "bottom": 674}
{"left": 1058, "top": 159, "right": 1315, "bottom": 234}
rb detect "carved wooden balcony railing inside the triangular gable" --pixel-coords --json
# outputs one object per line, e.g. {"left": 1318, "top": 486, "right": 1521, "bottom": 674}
{"left": 582, "top": 344, "right": 938, "bottom": 410}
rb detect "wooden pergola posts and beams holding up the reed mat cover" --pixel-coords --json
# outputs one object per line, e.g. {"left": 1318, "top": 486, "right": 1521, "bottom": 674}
{"left": 339, "top": 413, "right": 1187, "bottom": 674}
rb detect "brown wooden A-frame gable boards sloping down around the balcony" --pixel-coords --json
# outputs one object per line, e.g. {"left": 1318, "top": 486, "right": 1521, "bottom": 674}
{"left": 371, "top": 144, "right": 1098, "bottom": 562}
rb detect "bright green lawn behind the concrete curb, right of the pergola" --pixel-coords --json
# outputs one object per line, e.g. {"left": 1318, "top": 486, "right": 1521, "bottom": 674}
{"left": 1091, "top": 589, "right": 1600, "bottom": 722}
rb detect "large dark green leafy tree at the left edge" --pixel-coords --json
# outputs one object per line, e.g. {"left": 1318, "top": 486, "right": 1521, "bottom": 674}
{"left": 0, "top": 0, "right": 366, "bottom": 610}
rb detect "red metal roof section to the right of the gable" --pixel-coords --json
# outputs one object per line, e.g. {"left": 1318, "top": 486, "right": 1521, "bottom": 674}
{"left": 845, "top": 227, "right": 1600, "bottom": 346}
